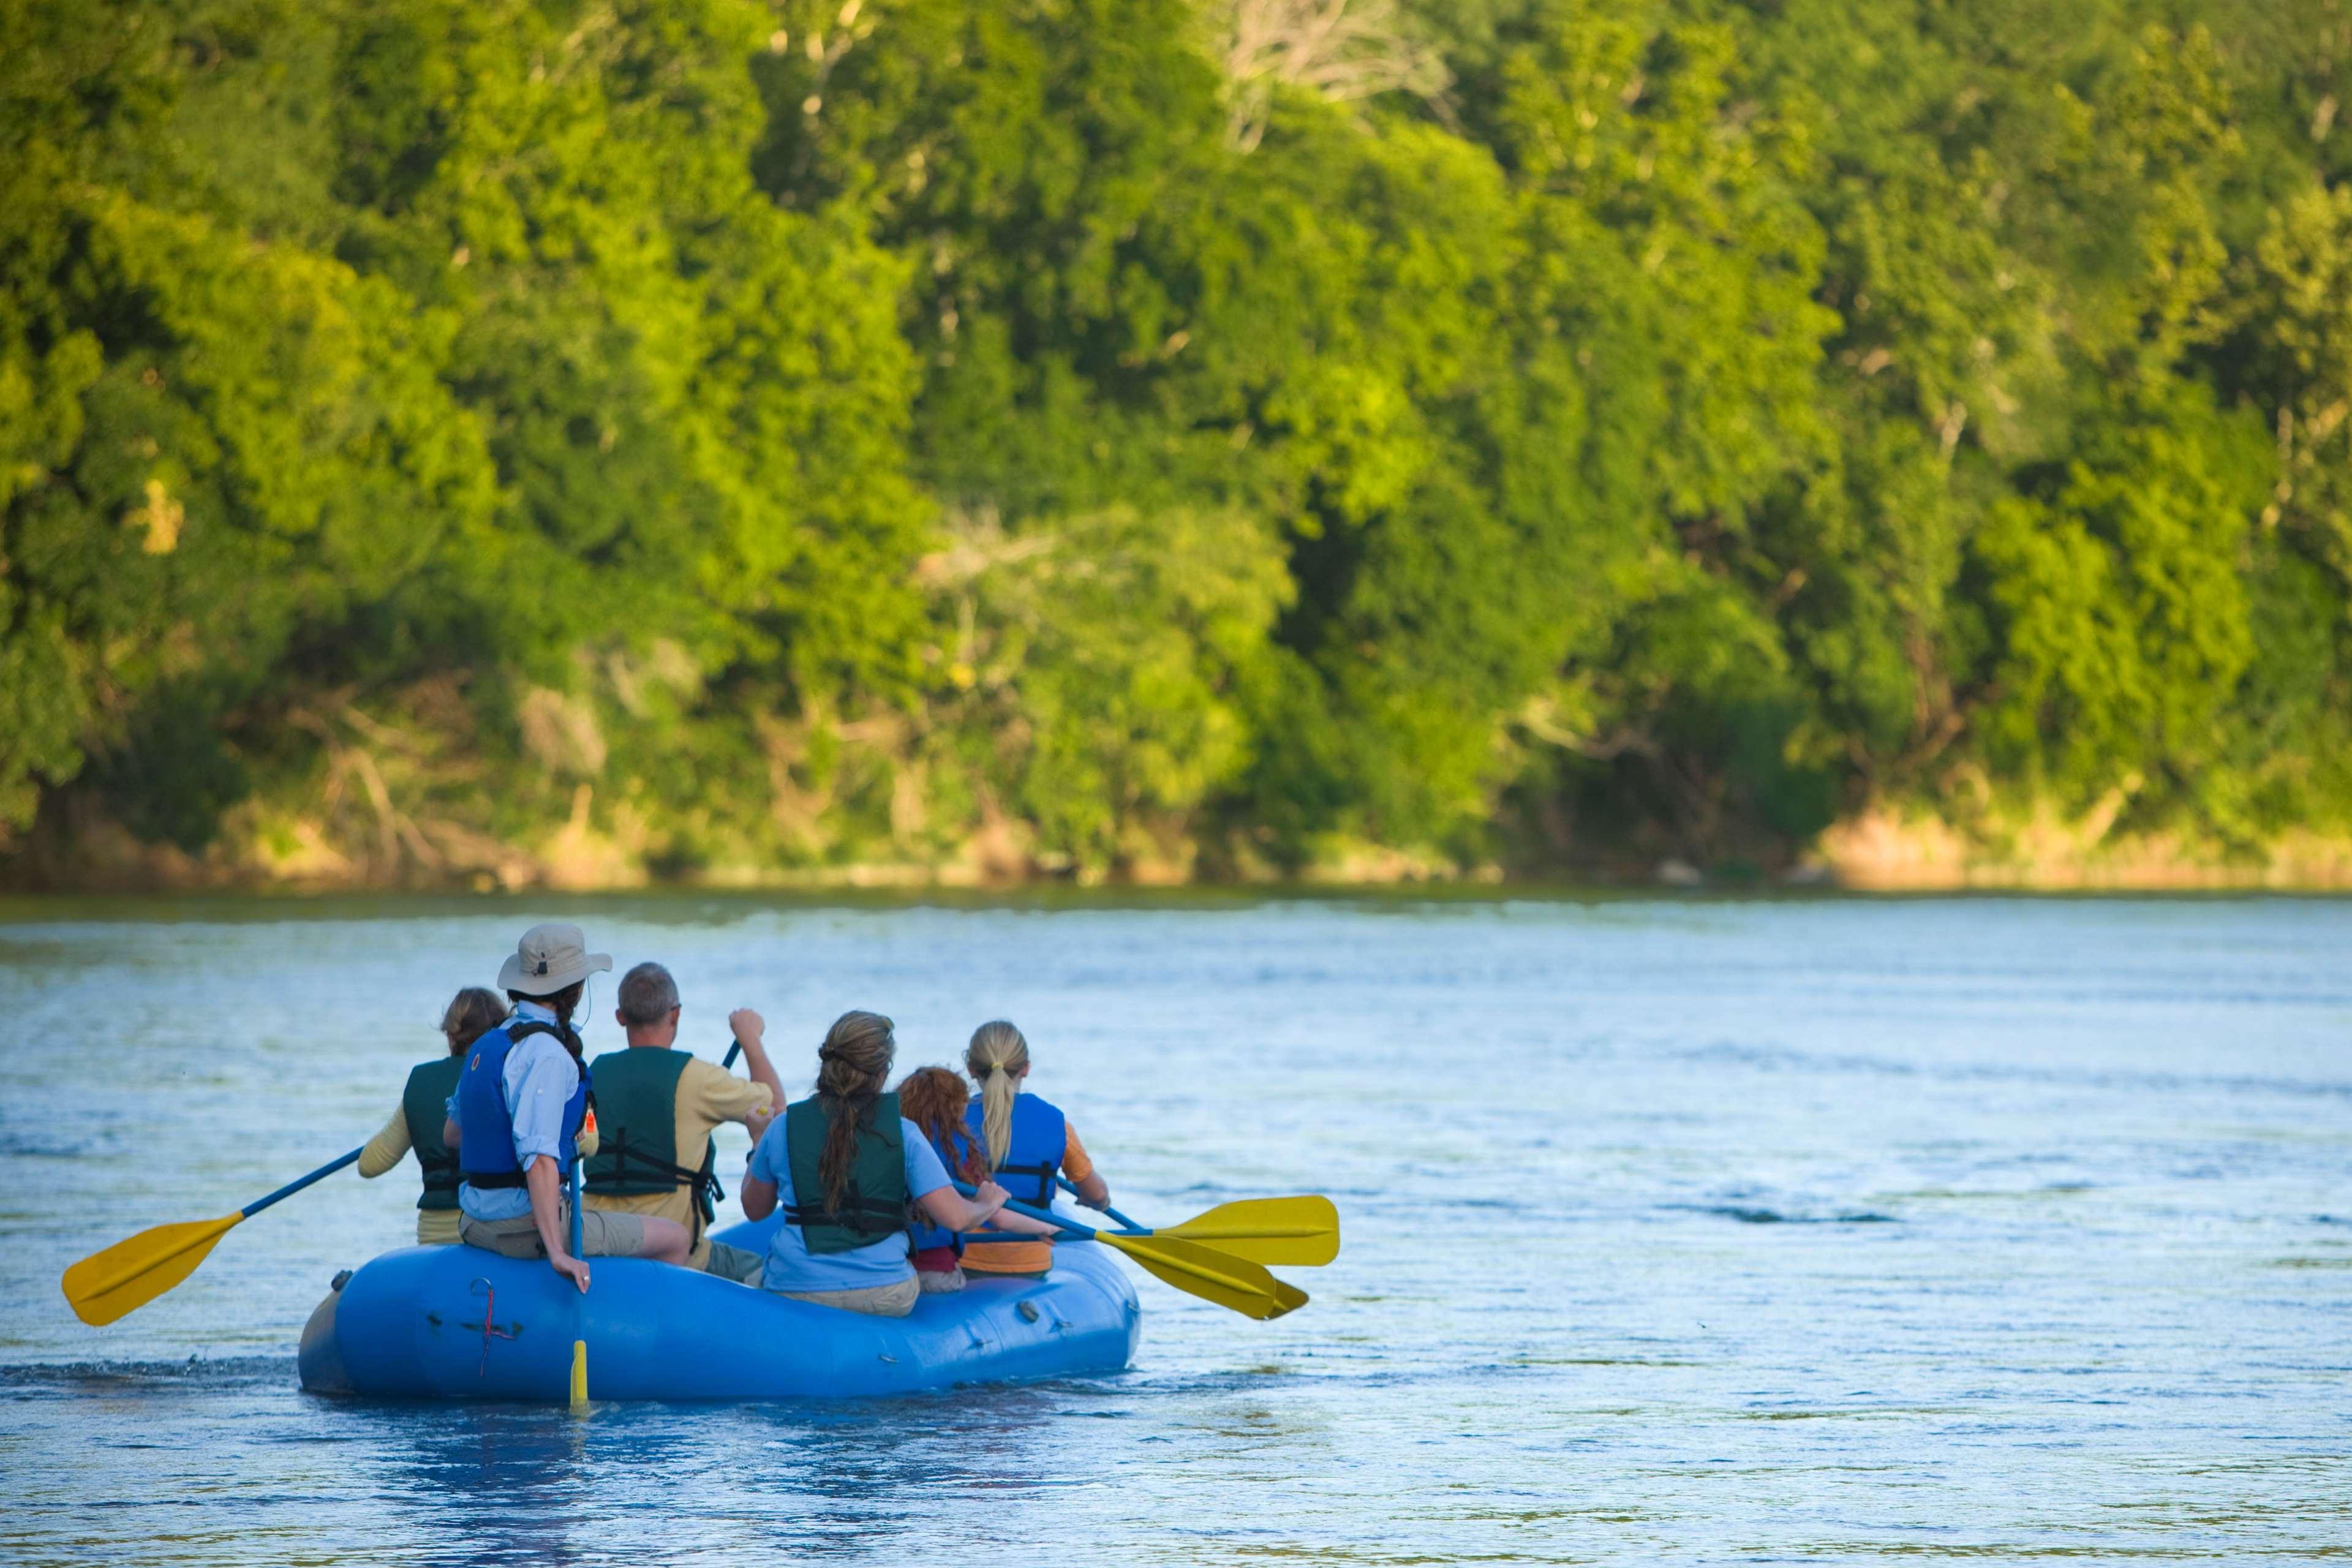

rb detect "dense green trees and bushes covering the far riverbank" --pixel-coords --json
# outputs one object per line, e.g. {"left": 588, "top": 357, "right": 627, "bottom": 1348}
{"left": 0, "top": 0, "right": 2352, "bottom": 881}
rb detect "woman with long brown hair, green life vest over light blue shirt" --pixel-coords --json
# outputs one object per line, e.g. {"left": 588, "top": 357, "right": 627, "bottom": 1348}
{"left": 743, "top": 1013, "right": 1044, "bottom": 1316}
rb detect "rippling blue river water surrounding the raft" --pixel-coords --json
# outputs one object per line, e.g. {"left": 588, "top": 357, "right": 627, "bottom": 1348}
{"left": 0, "top": 898, "right": 2352, "bottom": 1563}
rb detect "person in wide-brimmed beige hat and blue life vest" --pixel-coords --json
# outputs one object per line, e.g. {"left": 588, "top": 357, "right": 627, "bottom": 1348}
{"left": 442, "top": 922, "right": 687, "bottom": 1291}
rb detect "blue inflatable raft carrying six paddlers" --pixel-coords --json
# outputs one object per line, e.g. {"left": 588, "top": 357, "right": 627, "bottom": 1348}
{"left": 301, "top": 1218, "right": 1143, "bottom": 1403}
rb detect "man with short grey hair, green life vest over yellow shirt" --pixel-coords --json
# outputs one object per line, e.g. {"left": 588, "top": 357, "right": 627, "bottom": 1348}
{"left": 581, "top": 964, "right": 783, "bottom": 1286}
